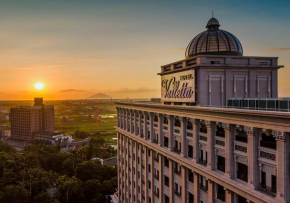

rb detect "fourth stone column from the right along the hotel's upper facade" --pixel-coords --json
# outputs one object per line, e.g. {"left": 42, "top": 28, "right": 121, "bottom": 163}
{"left": 205, "top": 121, "right": 216, "bottom": 170}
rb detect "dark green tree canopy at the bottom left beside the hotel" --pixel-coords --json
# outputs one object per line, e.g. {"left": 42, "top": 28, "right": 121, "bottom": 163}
{"left": 0, "top": 140, "right": 117, "bottom": 203}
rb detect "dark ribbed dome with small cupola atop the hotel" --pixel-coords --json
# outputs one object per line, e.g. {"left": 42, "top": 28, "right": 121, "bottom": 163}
{"left": 185, "top": 18, "right": 243, "bottom": 58}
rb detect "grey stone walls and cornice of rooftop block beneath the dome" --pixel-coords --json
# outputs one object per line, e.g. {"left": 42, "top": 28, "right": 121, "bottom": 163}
{"left": 159, "top": 55, "right": 283, "bottom": 107}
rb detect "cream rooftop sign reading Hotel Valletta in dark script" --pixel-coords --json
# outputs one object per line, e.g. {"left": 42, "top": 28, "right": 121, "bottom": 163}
{"left": 161, "top": 70, "right": 195, "bottom": 102}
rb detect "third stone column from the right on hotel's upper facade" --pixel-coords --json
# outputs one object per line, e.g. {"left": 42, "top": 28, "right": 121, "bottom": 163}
{"left": 222, "top": 123, "right": 235, "bottom": 179}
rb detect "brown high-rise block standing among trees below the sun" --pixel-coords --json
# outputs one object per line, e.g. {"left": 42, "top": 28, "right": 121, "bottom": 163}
{"left": 10, "top": 98, "right": 54, "bottom": 140}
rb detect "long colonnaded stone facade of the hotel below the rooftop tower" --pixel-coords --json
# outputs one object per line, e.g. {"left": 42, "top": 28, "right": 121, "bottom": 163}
{"left": 117, "top": 102, "right": 290, "bottom": 203}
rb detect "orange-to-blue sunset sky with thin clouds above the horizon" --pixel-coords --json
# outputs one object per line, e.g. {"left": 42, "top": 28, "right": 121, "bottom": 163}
{"left": 0, "top": 0, "right": 290, "bottom": 100}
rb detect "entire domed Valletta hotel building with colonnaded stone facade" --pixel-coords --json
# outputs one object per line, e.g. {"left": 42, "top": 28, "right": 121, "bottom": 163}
{"left": 115, "top": 18, "right": 290, "bottom": 203}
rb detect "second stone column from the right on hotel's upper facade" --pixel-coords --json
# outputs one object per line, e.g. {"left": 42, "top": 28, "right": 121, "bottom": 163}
{"left": 244, "top": 127, "right": 260, "bottom": 189}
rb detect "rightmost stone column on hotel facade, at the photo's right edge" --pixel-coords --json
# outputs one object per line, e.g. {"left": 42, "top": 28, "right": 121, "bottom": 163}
{"left": 273, "top": 131, "right": 290, "bottom": 202}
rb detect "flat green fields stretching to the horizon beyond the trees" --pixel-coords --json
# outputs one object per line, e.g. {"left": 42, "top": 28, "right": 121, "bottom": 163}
{"left": 0, "top": 100, "right": 117, "bottom": 144}
